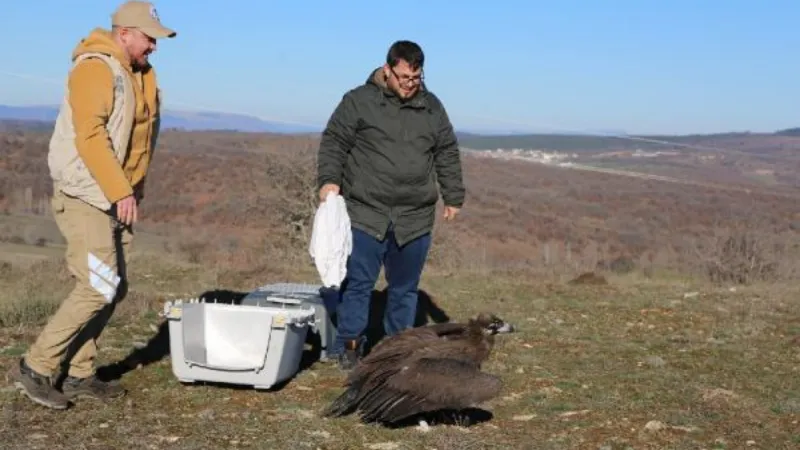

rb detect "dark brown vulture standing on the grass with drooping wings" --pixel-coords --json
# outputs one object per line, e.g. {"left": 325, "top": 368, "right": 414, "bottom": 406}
{"left": 322, "top": 313, "right": 514, "bottom": 424}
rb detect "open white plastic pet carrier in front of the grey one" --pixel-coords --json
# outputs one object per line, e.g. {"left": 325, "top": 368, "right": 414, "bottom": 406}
{"left": 164, "top": 290, "right": 319, "bottom": 389}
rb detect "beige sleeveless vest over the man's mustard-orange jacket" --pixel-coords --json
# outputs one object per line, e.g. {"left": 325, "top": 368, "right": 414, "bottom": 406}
{"left": 47, "top": 53, "right": 136, "bottom": 211}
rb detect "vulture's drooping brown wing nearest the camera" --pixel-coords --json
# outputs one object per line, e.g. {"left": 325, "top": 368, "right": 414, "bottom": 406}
{"left": 358, "top": 357, "right": 502, "bottom": 422}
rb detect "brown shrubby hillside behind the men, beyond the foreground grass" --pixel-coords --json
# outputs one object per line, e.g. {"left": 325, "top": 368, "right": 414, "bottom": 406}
{"left": 6, "top": 125, "right": 800, "bottom": 281}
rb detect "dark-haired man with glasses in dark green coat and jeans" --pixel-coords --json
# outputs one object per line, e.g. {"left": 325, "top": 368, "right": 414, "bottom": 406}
{"left": 317, "top": 41, "right": 464, "bottom": 370}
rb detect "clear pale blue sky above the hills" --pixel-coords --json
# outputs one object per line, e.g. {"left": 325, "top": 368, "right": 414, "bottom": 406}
{"left": 0, "top": 0, "right": 800, "bottom": 133}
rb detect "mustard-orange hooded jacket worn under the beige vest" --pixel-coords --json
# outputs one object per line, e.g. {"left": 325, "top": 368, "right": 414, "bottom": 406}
{"left": 68, "top": 28, "right": 160, "bottom": 203}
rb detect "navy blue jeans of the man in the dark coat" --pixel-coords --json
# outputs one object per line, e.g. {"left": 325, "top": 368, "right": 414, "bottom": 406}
{"left": 330, "top": 228, "right": 431, "bottom": 354}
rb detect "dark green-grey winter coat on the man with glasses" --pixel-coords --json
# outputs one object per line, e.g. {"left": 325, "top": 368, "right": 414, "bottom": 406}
{"left": 317, "top": 68, "right": 464, "bottom": 246}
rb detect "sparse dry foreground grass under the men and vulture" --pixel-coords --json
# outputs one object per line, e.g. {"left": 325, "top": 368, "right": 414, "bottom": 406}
{"left": 0, "top": 250, "right": 800, "bottom": 449}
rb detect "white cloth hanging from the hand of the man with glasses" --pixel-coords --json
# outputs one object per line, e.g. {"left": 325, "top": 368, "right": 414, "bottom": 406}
{"left": 308, "top": 192, "right": 353, "bottom": 287}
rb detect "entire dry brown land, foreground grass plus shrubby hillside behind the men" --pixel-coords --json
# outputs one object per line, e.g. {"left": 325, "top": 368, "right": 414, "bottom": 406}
{"left": 0, "top": 121, "right": 800, "bottom": 450}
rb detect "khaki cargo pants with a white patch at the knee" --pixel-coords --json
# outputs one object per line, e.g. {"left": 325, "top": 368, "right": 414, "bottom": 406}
{"left": 25, "top": 191, "right": 133, "bottom": 378}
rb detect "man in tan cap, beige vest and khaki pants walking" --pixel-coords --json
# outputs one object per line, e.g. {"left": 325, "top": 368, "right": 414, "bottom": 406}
{"left": 10, "top": 1, "right": 175, "bottom": 409}
